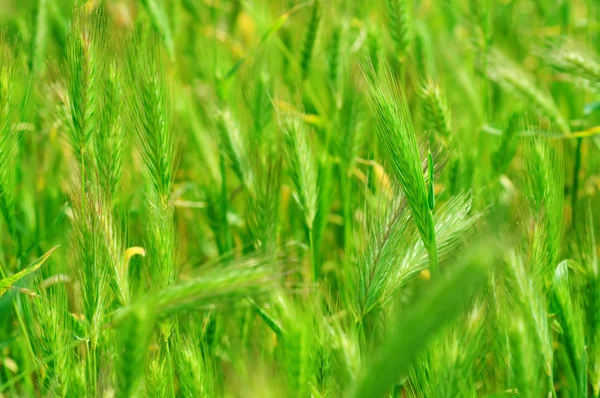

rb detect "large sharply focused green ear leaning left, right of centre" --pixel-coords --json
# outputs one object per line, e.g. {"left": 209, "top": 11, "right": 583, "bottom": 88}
{"left": 363, "top": 64, "right": 439, "bottom": 276}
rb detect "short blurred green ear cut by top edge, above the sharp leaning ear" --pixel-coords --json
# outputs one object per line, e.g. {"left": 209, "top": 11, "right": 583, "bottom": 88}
{"left": 385, "top": 0, "right": 414, "bottom": 61}
